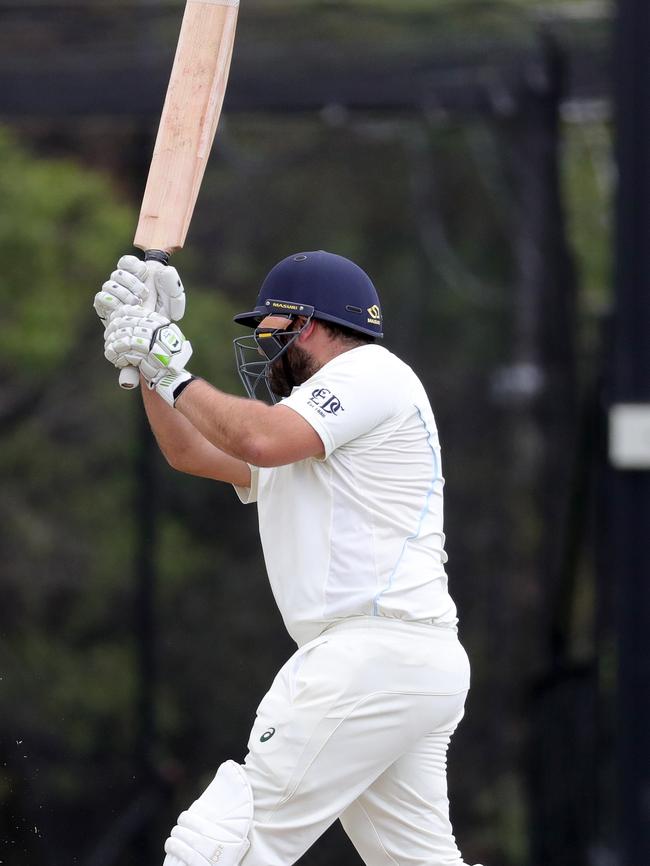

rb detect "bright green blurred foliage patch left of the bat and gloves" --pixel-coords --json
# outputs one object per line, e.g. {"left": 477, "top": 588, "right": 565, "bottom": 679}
{"left": 0, "top": 132, "right": 132, "bottom": 377}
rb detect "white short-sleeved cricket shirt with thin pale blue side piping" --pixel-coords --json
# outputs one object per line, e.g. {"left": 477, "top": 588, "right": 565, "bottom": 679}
{"left": 236, "top": 345, "right": 457, "bottom": 646}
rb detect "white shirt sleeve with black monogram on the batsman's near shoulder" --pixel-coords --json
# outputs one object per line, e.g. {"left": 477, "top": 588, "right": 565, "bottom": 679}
{"left": 282, "top": 353, "right": 403, "bottom": 457}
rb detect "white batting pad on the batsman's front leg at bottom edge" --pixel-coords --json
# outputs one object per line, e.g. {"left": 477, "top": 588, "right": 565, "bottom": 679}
{"left": 163, "top": 761, "right": 253, "bottom": 866}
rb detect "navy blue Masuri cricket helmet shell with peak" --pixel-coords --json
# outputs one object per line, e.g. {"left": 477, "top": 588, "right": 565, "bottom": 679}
{"left": 234, "top": 250, "right": 384, "bottom": 338}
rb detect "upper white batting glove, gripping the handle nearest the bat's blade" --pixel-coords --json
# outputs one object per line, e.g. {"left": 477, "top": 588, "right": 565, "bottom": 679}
{"left": 93, "top": 256, "right": 185, "bottom": 326}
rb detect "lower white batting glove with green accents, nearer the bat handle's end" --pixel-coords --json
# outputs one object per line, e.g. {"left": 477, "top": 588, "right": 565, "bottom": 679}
{"left": 104, "top": 306, "right": 194, "bottom": 406}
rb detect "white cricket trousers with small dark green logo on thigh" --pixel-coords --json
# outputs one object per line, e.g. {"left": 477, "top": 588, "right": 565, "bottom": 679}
{"left": 242, "top": 617, "right": 469, "bottom": 866}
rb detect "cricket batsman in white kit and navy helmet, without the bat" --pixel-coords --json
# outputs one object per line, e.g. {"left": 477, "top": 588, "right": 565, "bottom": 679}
{"left": 95, "top": 251, "right": 480, "bottom": 866}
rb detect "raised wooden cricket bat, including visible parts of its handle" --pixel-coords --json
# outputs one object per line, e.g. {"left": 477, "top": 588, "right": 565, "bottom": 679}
{"left": 120, "top": 0, "right": 239, "bottom": 388}
